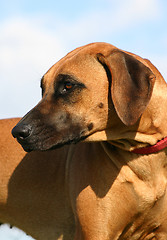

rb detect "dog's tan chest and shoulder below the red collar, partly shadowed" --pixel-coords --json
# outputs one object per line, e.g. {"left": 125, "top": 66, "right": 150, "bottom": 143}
{"left": 70, "top": 143, "right": 167, "bottom": 240}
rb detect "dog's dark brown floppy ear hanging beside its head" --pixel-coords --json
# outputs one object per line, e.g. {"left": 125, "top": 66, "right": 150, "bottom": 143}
{"left": 97, "top": 50, "right": 155, "bottom": 125}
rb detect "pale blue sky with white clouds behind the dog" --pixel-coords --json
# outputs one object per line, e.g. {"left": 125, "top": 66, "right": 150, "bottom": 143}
{"left": 0, "top": 0, "right": 167, "bottom": 240}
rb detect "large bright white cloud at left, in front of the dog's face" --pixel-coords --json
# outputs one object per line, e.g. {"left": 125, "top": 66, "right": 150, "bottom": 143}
{"left": 0, "top": 18, "right": 64, "bottom": 118}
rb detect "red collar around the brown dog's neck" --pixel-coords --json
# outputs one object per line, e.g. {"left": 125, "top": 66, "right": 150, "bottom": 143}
{"left": 132, "top": 137, "right": 167, "bottom": 154}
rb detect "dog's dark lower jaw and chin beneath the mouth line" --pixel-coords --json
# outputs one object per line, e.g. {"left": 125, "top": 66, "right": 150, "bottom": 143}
{"left": 20, "top": 136, "right": 88, "bottom": 152}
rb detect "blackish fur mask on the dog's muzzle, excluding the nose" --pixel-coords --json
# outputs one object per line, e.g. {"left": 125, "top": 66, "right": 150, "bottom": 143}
{"left": 12, "top": 105, "right": 90, "bottom": 152}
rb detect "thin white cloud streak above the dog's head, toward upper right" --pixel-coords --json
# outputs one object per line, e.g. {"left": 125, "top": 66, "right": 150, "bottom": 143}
{"left": 56, "top": 0, "right": 160, "bottom": 42}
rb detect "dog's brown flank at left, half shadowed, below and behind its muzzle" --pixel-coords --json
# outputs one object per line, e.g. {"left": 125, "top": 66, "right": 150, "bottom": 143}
{"left": 0, "top": 118, "right": 74, "bottom": 240}
